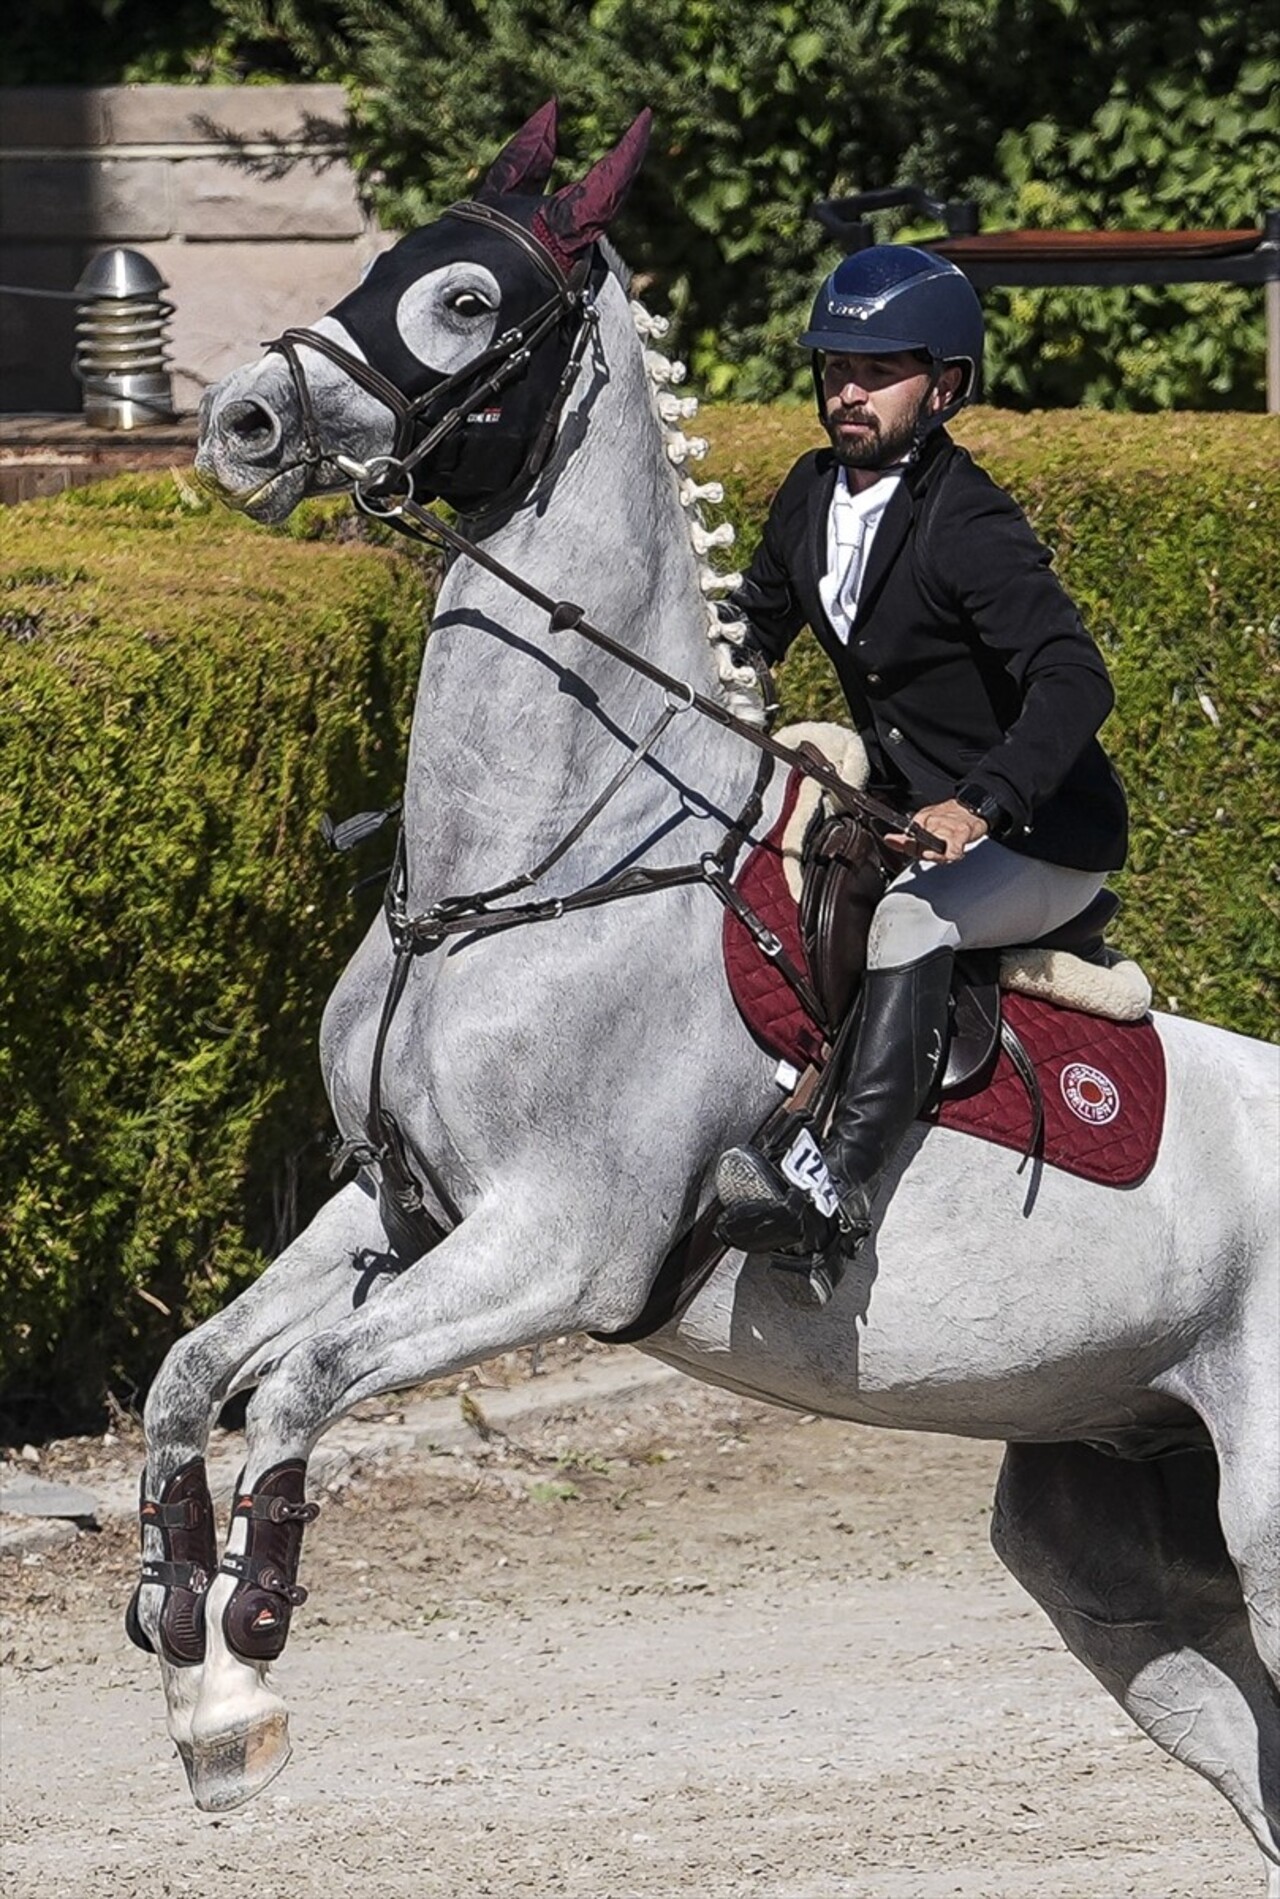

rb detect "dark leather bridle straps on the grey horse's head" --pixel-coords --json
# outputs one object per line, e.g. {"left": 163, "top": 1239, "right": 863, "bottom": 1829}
{"left": 264, "top": 201, "right": 598, "bottom": 507}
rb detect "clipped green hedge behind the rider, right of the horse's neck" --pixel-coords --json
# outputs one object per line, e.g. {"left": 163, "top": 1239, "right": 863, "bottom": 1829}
{"left": 706, "top": 398, "right": 1280, "bottom": 1039}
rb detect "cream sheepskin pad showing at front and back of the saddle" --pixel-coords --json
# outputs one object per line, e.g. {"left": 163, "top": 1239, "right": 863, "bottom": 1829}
{"left": 775, "top": 720, "right": 1151, "bottom": 1022}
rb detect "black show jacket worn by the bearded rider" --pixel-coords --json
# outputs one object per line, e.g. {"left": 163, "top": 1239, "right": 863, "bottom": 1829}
{"left": 725, "top": 429, "right": 1128, "bottom": 870}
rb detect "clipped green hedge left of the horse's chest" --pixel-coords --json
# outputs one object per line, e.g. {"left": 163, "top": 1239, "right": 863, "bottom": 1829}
{"left": 0, "top": 480, "right": 422, "bottom": 1422}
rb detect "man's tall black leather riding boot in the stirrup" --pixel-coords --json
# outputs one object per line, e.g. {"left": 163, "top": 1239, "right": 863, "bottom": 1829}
{"left": 716, "top": 950, "right": 955, "bottom": 1297}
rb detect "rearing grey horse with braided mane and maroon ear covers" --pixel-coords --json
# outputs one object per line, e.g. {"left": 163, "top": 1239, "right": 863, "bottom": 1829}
{"left": 131, "top": 108, "right": 1280, "bottom": 1899}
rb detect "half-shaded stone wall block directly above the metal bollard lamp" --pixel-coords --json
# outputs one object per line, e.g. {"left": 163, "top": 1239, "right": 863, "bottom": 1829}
{"left": 0, "top": 156, "right": 173, "bottom": 245}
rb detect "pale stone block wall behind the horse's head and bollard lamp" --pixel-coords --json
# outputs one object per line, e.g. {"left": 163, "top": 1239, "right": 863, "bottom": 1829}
{"left": 0, "top": 85, "right": 389, "bottom": 414}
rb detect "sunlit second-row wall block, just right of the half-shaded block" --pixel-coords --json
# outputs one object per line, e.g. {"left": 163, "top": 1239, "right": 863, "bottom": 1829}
{"left": 173, "top": 156, "right": 365, "bottom": 239}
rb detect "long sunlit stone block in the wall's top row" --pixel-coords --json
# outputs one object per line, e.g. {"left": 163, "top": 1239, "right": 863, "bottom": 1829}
{"left": 97, "top": 85, "right": 348, "bottom": 144}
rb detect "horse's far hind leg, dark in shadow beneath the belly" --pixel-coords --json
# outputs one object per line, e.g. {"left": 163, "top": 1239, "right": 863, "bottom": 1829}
{"left": 991, "top": 1443, "right": 1280, "bottom": 1876}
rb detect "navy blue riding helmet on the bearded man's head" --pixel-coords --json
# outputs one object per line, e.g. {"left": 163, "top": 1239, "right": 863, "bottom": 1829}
{"left": 800, "top": 243, "right": 982, "bottom": 433}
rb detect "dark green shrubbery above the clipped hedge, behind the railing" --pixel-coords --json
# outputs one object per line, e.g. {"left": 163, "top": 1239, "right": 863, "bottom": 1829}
{"left": 208, "top": 0, "right": 1280, "bottom": 408}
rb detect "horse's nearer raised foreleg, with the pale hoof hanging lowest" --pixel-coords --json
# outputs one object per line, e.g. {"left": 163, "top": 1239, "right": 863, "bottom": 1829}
{"left": 182, "top": 1208, "right": 621, "bottom": 1810}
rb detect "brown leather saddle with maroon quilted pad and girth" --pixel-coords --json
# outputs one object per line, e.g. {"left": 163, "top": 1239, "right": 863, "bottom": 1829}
{"left": 594, "top": 755, "right": 1164, "bottom": 1344}
